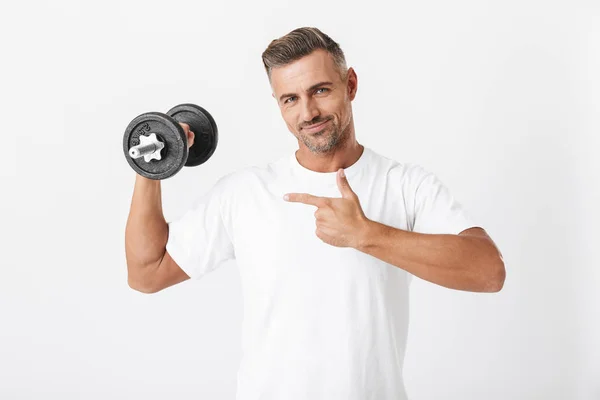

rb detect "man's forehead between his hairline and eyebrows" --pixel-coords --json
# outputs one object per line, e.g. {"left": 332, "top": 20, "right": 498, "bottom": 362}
{"left": 271, "top": 49, "right": 340, "bottom": 94}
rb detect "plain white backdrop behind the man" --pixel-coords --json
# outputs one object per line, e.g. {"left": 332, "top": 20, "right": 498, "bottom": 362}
{"left": 0, "top": 0, "right": 600, "bottom": 400}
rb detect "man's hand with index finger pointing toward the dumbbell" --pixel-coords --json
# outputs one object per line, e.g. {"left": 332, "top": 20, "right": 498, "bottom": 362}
{"left": 284, "top": 169, "right": 370, "bottom": 248}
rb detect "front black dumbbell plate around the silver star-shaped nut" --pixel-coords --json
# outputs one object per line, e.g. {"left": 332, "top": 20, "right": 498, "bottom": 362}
{"left": 123, "top": 112, "right": 188, "bottom": 180}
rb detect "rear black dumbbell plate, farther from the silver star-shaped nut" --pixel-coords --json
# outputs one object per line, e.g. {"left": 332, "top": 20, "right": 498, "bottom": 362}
{"left": 167, "top": 104, "right": 219, "bottom": 167}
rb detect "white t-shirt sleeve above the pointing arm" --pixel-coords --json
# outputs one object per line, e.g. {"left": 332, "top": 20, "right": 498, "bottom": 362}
{"left": 412, "top": 168, "right": 478, "bottom": 235}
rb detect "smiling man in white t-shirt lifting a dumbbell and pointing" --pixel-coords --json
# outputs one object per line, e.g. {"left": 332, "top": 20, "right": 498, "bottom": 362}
{"left": 126, "top": 28, "right": 505, "bottom": 400}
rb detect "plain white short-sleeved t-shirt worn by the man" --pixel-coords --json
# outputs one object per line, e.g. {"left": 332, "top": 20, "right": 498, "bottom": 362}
{"left": 167, "top": 147, "right": 476, "bottom": 400}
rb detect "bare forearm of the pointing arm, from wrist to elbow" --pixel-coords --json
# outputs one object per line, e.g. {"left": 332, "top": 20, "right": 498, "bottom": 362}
{"left": 358, "top": 221, "right": 504, "bottom": 292}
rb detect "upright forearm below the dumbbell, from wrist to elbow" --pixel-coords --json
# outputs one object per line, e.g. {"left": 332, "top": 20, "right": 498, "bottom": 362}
{"left": 125, "top": 175, "right": 168, "bottom": 278}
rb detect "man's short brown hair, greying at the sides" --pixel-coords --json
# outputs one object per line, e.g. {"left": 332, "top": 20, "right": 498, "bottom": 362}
{"left": 262, "top": 27, "right": 347, "bottom": 82}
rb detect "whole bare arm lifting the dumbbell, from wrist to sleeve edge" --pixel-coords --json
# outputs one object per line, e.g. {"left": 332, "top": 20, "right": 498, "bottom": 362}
{"left": 125, "top": 175, "right": 190, "bottom": 293}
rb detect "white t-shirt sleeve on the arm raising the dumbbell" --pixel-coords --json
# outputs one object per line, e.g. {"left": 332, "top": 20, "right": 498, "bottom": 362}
{"left": 167, "top": 178, "right": 235, "bottom": 279}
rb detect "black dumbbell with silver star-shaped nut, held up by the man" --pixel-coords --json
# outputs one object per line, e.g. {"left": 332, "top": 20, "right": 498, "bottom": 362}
{"left": 123, "top": 104, "right": 218, "bottom": 180}
